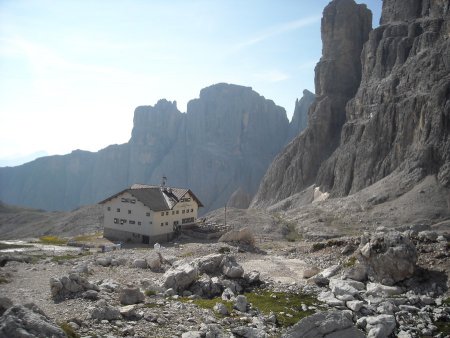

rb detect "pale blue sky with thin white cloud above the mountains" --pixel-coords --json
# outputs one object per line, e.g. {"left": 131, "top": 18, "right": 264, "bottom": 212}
{"left": 0, "top": 0, "right": 382, "bottom": 166}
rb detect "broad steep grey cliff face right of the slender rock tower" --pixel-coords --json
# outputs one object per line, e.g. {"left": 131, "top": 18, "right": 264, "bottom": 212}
{"left": 317, "top": 0, "right": 450, "bottom": 196}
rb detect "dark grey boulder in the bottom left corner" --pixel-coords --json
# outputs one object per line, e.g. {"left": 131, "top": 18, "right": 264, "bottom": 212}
{"left": 0, "top": 303, "right": 67, "bottom": 338}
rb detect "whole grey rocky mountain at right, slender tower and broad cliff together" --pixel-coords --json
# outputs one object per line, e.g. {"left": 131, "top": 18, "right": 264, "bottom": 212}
{"left": 252, "top": 0, "right": 450, "bottom": 217}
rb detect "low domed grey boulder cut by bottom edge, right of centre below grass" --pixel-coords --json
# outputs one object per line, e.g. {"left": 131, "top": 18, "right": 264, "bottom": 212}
{"left": 282, "top": 311, "right": 365, "bottom": 338}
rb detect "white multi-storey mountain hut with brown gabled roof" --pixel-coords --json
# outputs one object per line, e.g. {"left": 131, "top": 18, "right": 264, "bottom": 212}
{"left": 100, "top": 184, "right": 203, "bottom": 244}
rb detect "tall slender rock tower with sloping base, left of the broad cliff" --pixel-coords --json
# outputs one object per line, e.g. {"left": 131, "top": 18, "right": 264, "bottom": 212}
{"left": 252, "top": 0, "right": 372, "bottom": 207}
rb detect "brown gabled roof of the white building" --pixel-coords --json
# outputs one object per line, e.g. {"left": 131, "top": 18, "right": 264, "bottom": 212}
{"left": 99, "top": 184, "right": 203, "bottom": 211}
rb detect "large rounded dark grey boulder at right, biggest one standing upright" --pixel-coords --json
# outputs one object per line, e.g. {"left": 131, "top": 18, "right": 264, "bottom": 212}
{"left": 357, "top": 231, "right": 417, "bottom": 285}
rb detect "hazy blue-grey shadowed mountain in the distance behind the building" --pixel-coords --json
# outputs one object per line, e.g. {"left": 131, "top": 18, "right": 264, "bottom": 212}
{"left": 0, "top": 84, "right": 312, "bottom": 211}
